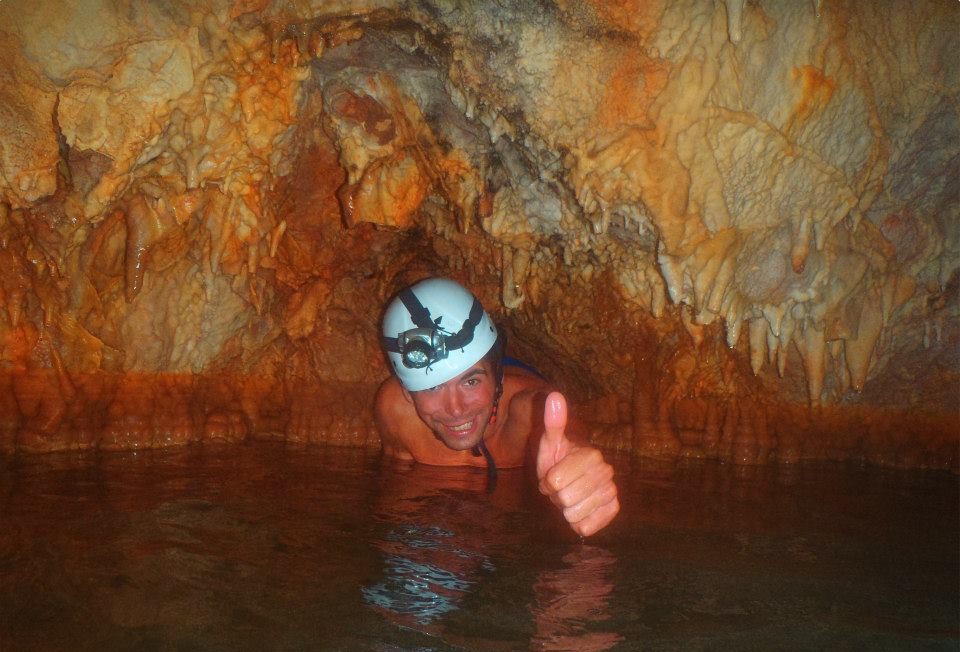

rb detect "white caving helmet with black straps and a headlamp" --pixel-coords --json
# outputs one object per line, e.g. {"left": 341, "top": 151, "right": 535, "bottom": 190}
{"left": 381, "top": 278, "right": 497, "bottom": 392}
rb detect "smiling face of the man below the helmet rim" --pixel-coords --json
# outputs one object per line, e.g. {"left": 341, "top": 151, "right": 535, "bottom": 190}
{"left": 410, "top": 359, "right": 497, "bottom": 451}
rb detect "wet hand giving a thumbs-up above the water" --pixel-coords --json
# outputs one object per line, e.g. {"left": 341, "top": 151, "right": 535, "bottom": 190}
{"left": 537, "top": 392, "right": 620, "bottom": 536}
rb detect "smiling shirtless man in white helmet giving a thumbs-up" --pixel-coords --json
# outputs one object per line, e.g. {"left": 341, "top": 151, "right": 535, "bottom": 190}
{"left": 375, "top": 278, "right": 620, "bottom": 536}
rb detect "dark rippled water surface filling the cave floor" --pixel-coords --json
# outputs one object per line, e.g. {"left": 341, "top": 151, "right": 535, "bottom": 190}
{"left": 0, "top": 444, "right": 960, "bottom": 652}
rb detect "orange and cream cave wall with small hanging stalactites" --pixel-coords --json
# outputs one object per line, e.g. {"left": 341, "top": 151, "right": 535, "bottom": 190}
{"left": 0, "top": 0, "right": 960, "bottom": 469}
